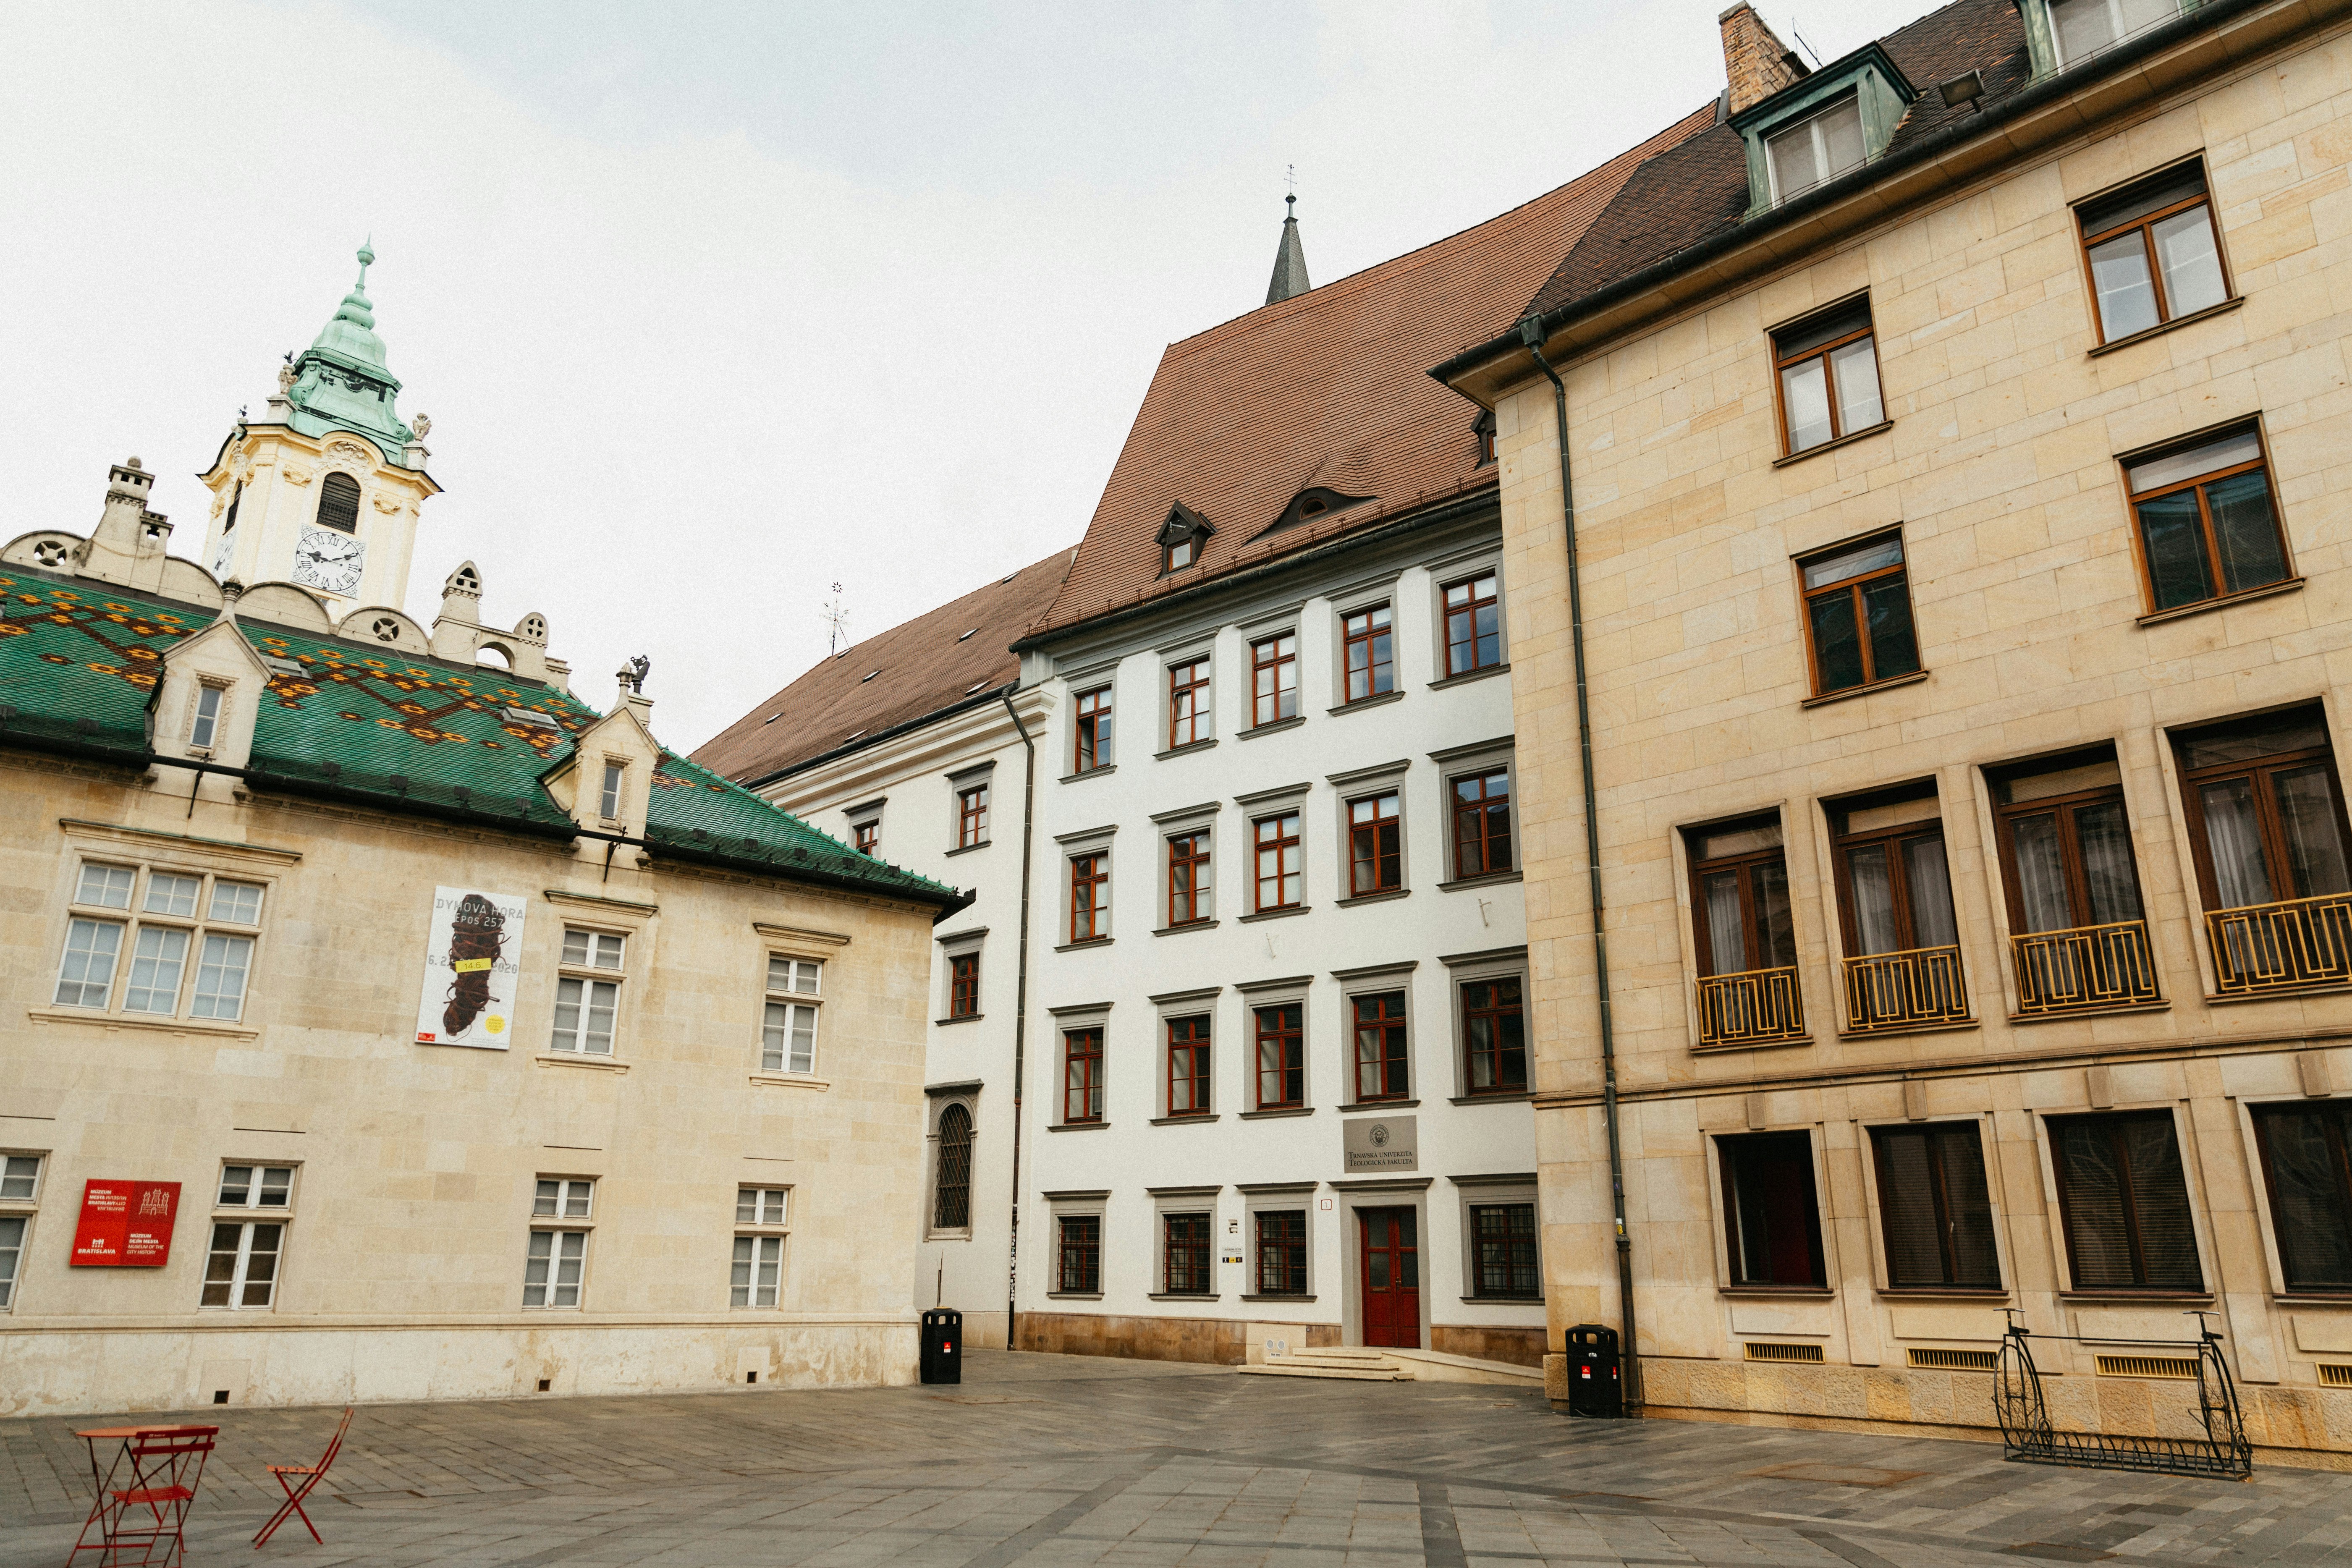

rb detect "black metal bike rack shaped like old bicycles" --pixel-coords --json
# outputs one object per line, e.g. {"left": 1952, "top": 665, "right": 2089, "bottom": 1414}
{"left": 1992, "top": 1309, "right": 2253, "bottom": 1481}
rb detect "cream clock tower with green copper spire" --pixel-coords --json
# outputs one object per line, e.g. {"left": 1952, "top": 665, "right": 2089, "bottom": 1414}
{"left": 200, "top": 244, "right": 440, "bottom": 620}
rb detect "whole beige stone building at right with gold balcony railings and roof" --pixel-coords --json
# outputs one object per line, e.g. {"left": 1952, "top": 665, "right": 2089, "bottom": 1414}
{"left": 1437, "top": 0, "right": 2352, "bottom": 1465}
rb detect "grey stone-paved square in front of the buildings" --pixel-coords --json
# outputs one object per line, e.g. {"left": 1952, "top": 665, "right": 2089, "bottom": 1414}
{"left": 0, "top": 1352, "right": 2352, "bottom": 1568}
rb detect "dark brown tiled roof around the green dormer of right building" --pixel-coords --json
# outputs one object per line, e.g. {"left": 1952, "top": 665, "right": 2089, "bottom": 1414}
{"left": 1514, "top": 0, "right": 2032, "bottom": 324}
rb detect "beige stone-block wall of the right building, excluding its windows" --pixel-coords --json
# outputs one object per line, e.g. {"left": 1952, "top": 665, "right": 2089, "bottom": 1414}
{"left": 1496, "top": 7, "right": 2352, "bottom": 1465}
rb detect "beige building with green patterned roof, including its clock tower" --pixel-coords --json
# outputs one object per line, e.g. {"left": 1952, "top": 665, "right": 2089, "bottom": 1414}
{"left": 0, "top": 251, "right": 964, "bottom": 1415}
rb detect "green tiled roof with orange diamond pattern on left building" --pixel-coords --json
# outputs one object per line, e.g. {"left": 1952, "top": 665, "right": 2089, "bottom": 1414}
{"left": 0, "top": 569, "right": 957, "bottom": 903}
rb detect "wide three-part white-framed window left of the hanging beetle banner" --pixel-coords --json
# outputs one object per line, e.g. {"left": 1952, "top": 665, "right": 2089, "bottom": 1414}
{"left": 52, "top": 860, "right": 263, "bottom": 1023}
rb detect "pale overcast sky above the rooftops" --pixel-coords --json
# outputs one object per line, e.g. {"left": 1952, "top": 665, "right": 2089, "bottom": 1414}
{"left": 0, "top": 0, "right": 1891, "bottom": 750}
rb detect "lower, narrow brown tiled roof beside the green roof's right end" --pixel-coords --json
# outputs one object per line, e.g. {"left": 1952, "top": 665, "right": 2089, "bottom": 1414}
{"left": 694, "top": 550, "right": 1070, "bottom": 783}
